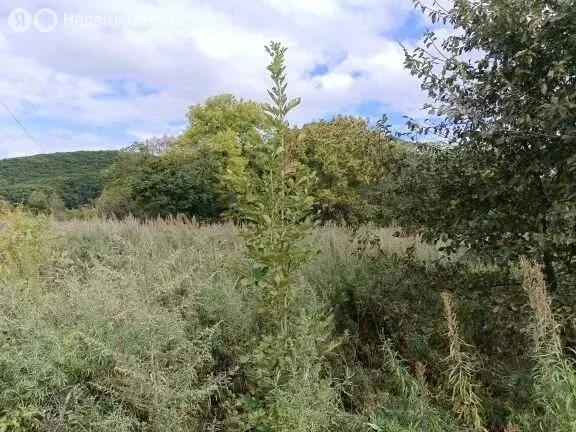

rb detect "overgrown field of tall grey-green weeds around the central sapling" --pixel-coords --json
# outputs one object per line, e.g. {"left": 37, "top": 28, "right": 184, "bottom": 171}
{"left": 0, "top": 210, "right": 576, "bottom": 431}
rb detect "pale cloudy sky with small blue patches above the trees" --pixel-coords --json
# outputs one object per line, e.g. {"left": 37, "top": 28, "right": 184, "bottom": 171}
{"left": 0, "top": 0, "right": 426, "bottom": 158}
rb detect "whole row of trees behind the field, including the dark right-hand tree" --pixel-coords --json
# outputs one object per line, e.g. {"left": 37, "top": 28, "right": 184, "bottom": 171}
{"left": 97, "top": 48, "right": 576, "bottom": 290}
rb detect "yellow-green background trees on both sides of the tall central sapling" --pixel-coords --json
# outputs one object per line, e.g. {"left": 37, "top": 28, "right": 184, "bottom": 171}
{"left": 97, "top": 94, "right": 416, "bottom": 224}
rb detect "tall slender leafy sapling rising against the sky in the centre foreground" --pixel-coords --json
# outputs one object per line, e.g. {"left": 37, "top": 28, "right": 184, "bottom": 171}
{"left": 237, "top": 42, "right": 314, "bottom": 323}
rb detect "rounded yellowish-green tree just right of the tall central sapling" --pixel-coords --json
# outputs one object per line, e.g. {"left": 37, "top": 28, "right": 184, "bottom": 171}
{"left": 288, "top": 116, "right": 401, "bottom": 223}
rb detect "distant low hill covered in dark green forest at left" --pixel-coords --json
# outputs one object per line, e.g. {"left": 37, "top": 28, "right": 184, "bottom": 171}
{"left": 0, "top": 151, "right": 118, "bottom": 208}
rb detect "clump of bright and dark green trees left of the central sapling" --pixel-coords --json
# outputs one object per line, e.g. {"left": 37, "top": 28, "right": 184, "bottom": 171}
{"left": 98, "top": 95, "right": 269, "bottom": 219}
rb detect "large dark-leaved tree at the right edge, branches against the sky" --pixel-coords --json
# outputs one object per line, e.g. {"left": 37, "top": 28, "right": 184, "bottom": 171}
{"left": 406, "top": 0, "right": 576, "bottom": 289}
